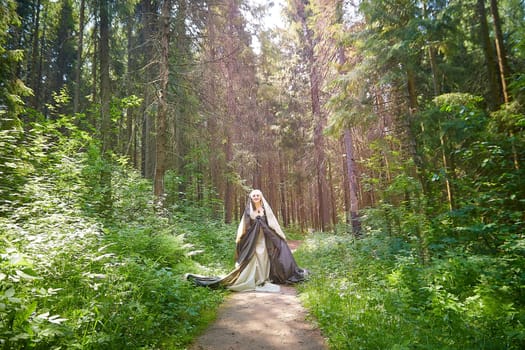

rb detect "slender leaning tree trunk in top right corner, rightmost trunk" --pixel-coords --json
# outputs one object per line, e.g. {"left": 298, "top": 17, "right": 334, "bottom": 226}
{"left": 477, "top": 0, "right": 502, "bottom": 110}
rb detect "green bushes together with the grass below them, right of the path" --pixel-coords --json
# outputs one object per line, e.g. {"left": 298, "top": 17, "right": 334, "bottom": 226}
{"left": 299, "top": 94, "right": 525, "bottom": 349}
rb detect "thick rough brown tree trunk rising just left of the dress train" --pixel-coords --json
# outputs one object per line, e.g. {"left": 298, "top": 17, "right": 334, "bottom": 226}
{"left": 153, "top": 0, "right": 171, "bottom": 205}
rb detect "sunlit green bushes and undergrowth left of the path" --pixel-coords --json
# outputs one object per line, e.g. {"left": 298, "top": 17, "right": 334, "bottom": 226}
{"left": 0, "top": 118, "right": 229, "bottom": 349}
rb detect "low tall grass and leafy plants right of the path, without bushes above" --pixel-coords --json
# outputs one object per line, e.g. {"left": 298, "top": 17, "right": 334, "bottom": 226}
{"left": 297, "top": 234, "right": 525, "bottom": 349}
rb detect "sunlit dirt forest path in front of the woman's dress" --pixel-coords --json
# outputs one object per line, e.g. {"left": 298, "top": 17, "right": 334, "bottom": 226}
{"left": 189, "top": 241, "right": 328, "bottom": 350}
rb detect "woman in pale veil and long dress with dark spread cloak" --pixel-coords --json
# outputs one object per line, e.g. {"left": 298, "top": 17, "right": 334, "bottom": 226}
{"left": 187, "top": 190, "right": 308, "bottom": 292}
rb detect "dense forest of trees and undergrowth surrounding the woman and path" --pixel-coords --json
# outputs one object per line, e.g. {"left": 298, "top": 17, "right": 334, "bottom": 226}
{"left": 0, "top": 0, "right": 525, "bottom": 349}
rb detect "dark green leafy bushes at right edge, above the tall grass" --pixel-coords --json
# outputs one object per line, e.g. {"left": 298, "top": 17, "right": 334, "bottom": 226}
{"left": 421, "top": 94, "right": 525, "bottom": 252}
